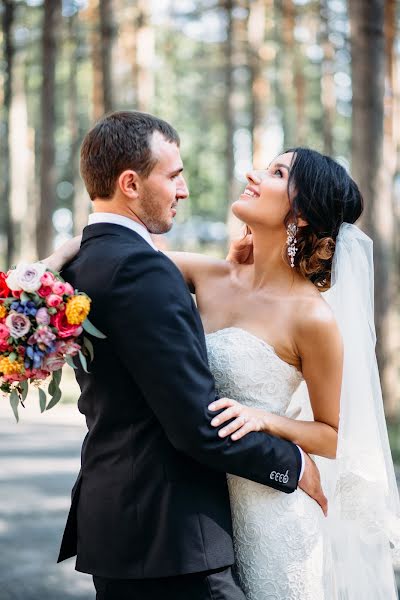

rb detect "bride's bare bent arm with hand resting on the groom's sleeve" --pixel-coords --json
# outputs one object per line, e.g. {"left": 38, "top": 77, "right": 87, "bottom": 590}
{"left": 210, "top": 305, "right": 343, "bottom": 458}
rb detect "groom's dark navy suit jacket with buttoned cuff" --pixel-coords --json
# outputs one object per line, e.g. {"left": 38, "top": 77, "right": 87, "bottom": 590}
{"left": 59, "top": 224, "right": 300, "bottom": 578}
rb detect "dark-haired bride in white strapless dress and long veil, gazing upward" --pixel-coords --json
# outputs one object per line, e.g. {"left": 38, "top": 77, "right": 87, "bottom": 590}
{"left": 51, "top": 148, "right": 400, "bottom": 600}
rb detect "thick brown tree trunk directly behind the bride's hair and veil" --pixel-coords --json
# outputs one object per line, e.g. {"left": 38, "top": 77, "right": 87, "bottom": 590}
{"left": 349, "top": 0, "right": 393, "bottom": 405}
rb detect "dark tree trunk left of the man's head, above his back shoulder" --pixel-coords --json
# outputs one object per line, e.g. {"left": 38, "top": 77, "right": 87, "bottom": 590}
{"left": 37, "top": 0, "right": 62, "bottom": 258}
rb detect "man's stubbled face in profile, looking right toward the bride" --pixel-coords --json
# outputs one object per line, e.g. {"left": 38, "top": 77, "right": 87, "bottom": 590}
{"left": 138, "top": 131, "right": 189, "bottom": 233}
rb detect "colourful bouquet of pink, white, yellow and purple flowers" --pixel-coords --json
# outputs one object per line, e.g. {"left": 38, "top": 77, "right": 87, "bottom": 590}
{"left": 0, "top": 263, "right": 105, "bottom": 421}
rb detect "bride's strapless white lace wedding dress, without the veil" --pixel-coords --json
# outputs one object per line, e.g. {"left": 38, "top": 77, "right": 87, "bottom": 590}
{"left": 206, "top": 327, "right": 324, "bottom": 600}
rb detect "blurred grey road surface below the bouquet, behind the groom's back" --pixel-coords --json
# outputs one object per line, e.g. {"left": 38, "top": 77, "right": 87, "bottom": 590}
{"left": 0, "top": 398, "right": 400, "bottom": 600}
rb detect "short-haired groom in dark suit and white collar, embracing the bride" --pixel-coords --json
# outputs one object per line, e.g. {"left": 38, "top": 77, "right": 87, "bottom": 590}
{"left": 59, "top": 112, "right": 325, "bottom": 600}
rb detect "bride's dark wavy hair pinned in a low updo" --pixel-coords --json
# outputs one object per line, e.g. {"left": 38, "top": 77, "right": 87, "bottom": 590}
{"left": 285, "top": 147, "right": 363, "bottom": 291}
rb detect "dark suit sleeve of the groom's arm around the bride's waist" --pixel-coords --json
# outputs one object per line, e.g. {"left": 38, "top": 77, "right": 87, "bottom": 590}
{"left": 107, "top": 253, "right": 301, "bottom": 493}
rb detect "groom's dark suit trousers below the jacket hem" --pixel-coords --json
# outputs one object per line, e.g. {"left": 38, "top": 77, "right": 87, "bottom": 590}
{"left": 93, "top": 567, "right": 245, "bottom": 600}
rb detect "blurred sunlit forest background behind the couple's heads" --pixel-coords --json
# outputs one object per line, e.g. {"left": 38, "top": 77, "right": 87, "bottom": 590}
{"left": 0, "top": 0, "right": 400, "bottom": 414}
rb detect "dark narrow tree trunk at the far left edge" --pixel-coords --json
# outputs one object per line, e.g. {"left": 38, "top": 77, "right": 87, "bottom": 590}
{"left": 2, "top": 0, "right": 15, "bottom": 268}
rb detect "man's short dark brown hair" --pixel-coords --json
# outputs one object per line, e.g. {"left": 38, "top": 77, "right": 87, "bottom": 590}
{"left": 80, "top": 111, "right": 180, "bottom": 200}
